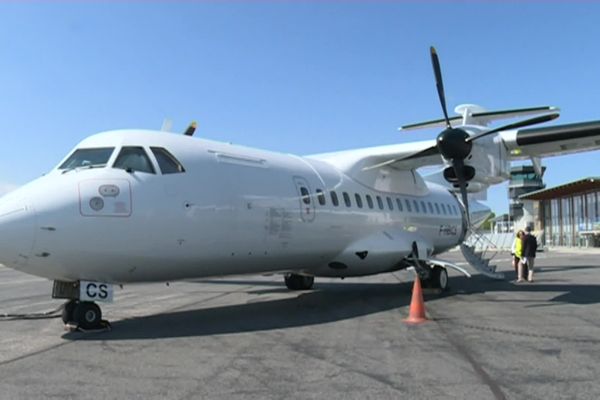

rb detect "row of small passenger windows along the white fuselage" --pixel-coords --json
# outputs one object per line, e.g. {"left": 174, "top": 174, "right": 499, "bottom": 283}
{"left": 300, "top": 187, "right": 459, "bottom": 215}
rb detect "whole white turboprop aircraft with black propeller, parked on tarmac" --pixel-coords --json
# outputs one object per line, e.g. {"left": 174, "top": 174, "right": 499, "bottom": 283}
{"left": 0, "top": 48, "right": 600, "bottom": 329}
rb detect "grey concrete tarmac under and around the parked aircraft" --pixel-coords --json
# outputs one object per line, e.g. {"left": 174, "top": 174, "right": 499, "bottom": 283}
{"left": 0, "top": 252, "right": 600, "bottom": 400}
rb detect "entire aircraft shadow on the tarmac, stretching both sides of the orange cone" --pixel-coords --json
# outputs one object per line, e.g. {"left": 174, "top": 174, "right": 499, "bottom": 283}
{"left": 63, "top": 267, "right": 600, "bottom": 340}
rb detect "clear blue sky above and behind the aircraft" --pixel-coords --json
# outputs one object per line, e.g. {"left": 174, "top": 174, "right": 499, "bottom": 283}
{"left": 0, "top": 1, "right": 600, "bottom": 216}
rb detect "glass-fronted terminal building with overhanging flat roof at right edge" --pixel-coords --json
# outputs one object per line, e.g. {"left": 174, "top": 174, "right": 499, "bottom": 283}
{"left": 519, "top": 177, "right": 600, "bottom": 247}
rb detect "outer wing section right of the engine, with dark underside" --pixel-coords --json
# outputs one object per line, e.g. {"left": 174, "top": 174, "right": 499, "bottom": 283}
{"left": 500, "top": 121, "right": 600, "bottom": 160}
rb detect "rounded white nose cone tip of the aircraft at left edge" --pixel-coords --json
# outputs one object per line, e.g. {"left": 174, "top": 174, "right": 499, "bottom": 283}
{"left": 0, "top": 199, "right": 35, "bottom": 269}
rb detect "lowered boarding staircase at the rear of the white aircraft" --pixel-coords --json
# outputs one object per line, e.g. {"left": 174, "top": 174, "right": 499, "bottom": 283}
{"left": 460, "top": 230, "right": 504, "bottom": 279}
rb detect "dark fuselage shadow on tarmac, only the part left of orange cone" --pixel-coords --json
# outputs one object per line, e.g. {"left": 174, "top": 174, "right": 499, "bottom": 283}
{"left": 63, "top": 281, "right": 418, "bottom": 340}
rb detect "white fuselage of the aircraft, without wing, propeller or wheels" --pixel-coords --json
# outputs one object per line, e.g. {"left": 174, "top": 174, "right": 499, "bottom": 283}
{"left": 0, "top": 131, "right": 476, "bottom": 283}
